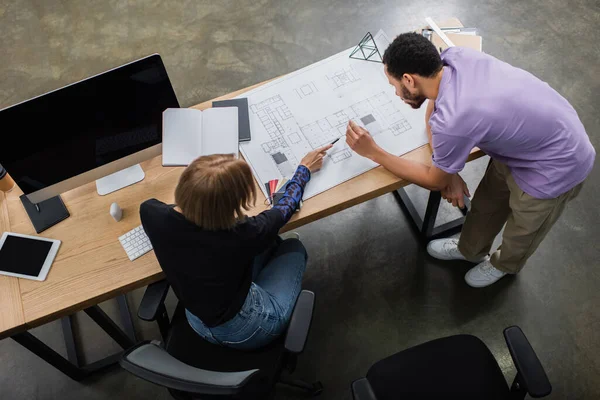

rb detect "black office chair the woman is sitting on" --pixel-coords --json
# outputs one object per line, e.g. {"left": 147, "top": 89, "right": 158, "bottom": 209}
{"left": 120, "top": 281, "right": 323, "bottom": 400}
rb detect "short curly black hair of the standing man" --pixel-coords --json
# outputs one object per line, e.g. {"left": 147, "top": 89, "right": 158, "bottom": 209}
{"left": 383, "top": 32, "right": 444, "bottom": 79}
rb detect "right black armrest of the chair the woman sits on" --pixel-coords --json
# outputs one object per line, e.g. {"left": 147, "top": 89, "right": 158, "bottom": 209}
{"left": 285, "top": 290, "right": 315, "bottom": 354}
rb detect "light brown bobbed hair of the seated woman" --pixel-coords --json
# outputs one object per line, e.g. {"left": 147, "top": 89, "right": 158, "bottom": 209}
{"left": 175, "top": 154, "right": 256, "bottom": 231}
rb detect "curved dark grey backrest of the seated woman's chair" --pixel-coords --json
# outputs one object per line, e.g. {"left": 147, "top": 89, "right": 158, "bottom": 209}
{"left": 120, "top": 342, "right": 259, "bottom": 396}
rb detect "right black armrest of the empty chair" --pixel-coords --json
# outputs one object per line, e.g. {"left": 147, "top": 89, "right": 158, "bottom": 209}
{"left": 504, "top": 326, "right": 552, "bottom": 398}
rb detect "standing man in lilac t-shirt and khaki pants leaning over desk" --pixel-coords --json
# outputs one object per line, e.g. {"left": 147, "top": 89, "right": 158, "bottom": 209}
{"left": 346, "top": 33, "right": 596, "bottom": 287}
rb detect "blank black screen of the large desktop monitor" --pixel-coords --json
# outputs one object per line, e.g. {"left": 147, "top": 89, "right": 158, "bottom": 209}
{"left": 0, "top": 55, "right": 179, "bottom": 194}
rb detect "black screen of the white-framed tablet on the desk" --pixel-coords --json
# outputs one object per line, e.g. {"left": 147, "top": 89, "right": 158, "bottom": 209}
{"left": 0, "top": 235, "right": 52, "bottom": 277}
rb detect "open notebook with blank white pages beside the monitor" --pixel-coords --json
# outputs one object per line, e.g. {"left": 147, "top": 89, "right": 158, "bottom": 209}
{"left": 163, "top": 107, "right": 239, "bottom": 167}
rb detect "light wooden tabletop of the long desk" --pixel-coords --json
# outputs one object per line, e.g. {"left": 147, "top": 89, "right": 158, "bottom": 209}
{"left": 0, "top": 18, "right": 483, "bottom": 338}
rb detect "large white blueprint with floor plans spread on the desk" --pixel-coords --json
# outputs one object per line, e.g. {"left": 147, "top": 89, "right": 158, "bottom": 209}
{"left": 240, "top": 31, "right": 427, "bottom": 199}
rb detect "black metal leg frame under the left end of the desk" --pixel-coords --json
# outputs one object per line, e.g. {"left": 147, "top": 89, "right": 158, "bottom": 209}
{"left": 12, "top": 295, "right": 135, "bottom": 381}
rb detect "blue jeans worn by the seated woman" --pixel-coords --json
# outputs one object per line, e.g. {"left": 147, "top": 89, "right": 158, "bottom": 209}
{"left": 185, "top": 239, "right": 307, "bottom": 350}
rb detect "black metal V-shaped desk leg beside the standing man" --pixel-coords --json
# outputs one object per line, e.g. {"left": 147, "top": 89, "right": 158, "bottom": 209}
{"left": 394, "top": 188, "right": 471, "bottom": 241}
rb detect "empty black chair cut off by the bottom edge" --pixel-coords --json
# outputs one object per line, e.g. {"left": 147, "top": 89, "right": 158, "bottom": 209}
{"left": 352, "top": 326, "right": 552, "bottom": 400}
